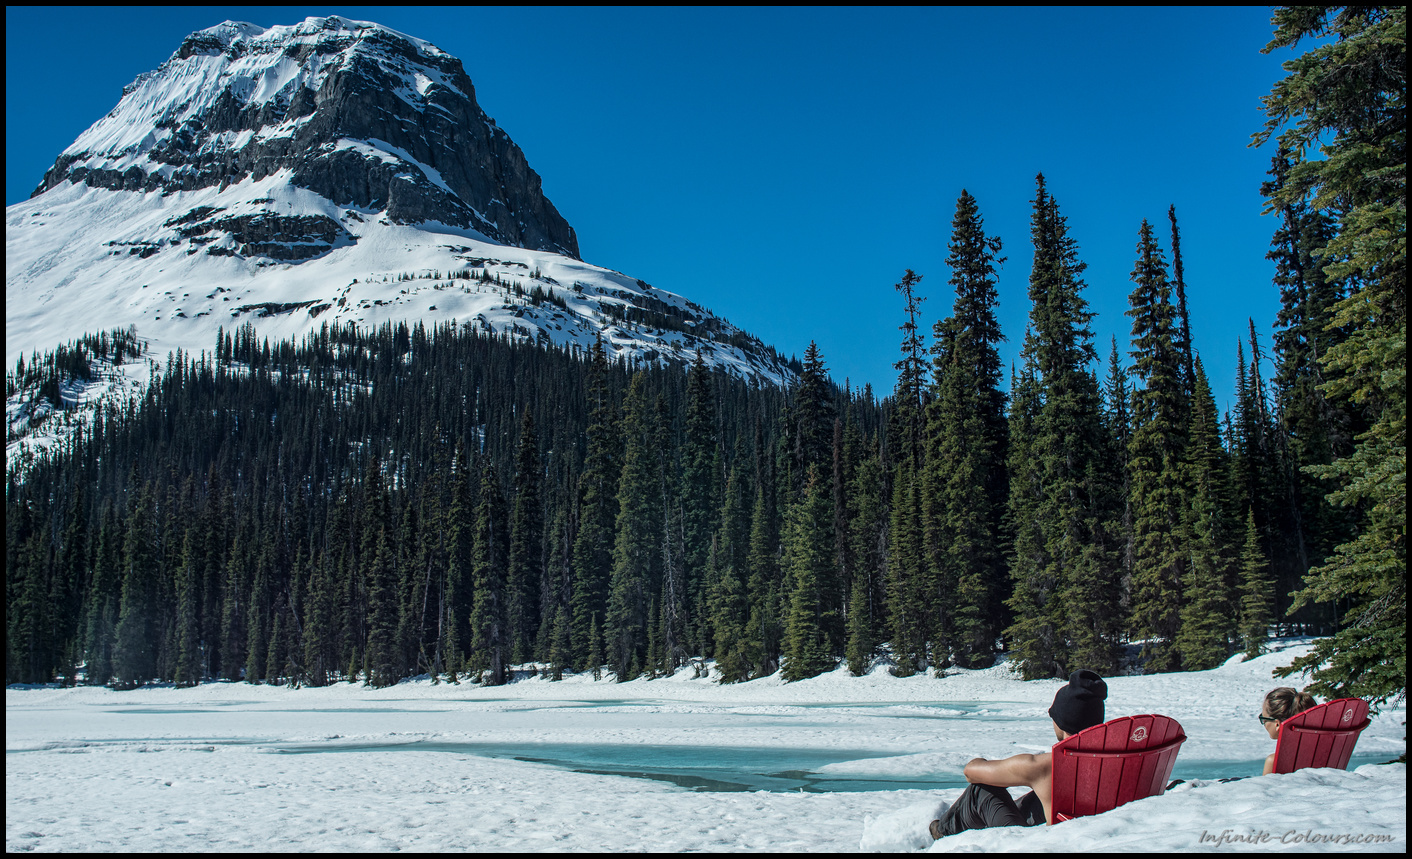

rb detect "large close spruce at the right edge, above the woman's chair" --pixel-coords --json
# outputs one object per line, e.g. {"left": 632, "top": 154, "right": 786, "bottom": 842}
{"left": 1255, "top": 6, "right": 1406, "bottom": 702}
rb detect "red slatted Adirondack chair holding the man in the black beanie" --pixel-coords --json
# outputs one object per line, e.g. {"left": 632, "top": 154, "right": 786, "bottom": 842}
{"left": 1049, "top": 715, "right": 1186, "bottom": 824}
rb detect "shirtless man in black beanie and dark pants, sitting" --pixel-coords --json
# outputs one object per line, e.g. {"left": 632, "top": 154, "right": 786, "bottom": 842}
{"left": 932, "top": 668, "right": 1108, "bottom": 838}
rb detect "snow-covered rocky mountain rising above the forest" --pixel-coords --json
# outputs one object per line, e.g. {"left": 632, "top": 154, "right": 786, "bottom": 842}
{"left": 6, "top": 17, "right": 792, "bottom": 432}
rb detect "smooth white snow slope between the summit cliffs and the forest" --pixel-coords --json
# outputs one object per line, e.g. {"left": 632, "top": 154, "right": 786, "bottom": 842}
{"left": 6, "top": 175, "right": 788, "bottom": 384}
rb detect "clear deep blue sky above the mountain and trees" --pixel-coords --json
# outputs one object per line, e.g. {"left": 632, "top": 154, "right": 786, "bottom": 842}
{"left": 6, "top": 6, "right": 1293, "bottom": 408}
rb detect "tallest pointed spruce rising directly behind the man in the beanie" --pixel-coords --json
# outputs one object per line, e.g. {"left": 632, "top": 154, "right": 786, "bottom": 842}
{"left": 1007, "top": 175, "right": 1123, "bottom": 677}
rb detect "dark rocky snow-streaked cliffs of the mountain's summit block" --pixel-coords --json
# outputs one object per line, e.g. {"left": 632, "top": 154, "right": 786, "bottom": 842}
{"left": 34, "top": 17, "right": 579, "bottom": 261}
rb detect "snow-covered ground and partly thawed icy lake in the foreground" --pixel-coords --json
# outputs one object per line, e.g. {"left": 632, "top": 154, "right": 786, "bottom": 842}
{"left": 6, "top": 643, "right": 1406, "bottom": 852}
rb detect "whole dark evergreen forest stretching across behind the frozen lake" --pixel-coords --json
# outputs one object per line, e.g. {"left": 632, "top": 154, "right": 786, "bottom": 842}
{"left": 6, "top": 7, "right": 1406, "bottom": 701}
